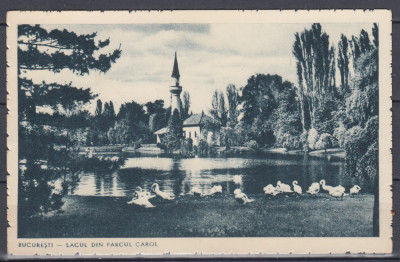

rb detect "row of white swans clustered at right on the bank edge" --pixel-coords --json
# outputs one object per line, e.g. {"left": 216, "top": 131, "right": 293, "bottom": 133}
{"left": 264, "top": 179, "right": 361, "bottom": 199}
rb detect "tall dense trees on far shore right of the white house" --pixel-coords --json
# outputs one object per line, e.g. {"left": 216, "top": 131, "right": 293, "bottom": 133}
{"left": 210, "top": 24, "right": 379, "bottom": 159}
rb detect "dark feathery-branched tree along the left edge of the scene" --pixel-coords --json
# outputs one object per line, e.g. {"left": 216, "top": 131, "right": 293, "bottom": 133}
{"left": 18, "top": 25, "right": 121, "bottom": 216}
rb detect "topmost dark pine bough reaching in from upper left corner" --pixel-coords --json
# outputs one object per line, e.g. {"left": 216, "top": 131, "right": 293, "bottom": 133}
{"left": 18, "top": 25, "right": 121, "bottom": 75}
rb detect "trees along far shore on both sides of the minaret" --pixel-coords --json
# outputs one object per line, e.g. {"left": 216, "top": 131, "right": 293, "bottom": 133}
{"left": 21, "top": 24, "right": 379, "bottom": 160}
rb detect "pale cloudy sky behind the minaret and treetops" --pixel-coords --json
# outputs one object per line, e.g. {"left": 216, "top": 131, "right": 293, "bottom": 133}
{"left": 23, "top": 23, "right": 372, "bottom": 113}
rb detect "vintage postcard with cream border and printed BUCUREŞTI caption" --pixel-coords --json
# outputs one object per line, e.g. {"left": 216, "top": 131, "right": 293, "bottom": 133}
{"left": 7, "top": 10, "right": 392, "bottom": 256}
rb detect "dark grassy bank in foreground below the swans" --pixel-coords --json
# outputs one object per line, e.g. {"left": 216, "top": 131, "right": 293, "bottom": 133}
{"left": 19, "top": 194, "right": 374, "bottom": 238}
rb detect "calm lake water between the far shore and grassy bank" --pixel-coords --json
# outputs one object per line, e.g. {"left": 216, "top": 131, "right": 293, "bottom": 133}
{"left": 73, "top": 154, "right": 372, "bottom": 197}
